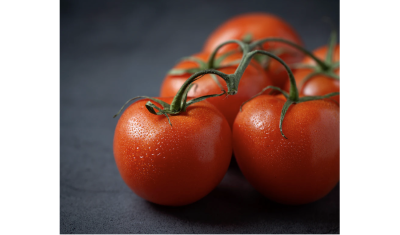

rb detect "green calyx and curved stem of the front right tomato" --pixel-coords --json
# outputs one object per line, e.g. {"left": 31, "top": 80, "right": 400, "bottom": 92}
{"left": 239, "top": 50, "right": 340, "bottom": 139}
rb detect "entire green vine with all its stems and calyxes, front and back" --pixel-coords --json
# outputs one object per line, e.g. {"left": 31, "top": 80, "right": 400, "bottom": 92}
{"left": 114, "top": 34, "right": 340, "bottom": 132}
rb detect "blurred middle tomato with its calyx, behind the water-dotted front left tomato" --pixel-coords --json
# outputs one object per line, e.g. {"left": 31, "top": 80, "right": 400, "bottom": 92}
{"left": 160, "top": 47, "right": 273, "bottom": 126}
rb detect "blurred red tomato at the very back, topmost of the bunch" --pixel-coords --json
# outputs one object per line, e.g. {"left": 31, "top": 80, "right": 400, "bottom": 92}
{"left": 203, "top": 13, "right": 304, "bottom": 89}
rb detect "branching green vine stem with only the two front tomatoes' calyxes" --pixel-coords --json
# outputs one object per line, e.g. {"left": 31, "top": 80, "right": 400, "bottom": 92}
{"left": 114, "top": 38, "right": 340, "bottom": 132}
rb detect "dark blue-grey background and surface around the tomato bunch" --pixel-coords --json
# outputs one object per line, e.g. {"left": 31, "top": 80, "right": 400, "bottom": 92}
{"left": 59, "top": 0, "right": 340, "bottom": 234}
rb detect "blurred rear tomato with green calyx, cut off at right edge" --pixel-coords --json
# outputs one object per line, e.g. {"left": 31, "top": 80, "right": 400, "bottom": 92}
{"left": 285, "top": 32, "right": 340, "bottom": 105}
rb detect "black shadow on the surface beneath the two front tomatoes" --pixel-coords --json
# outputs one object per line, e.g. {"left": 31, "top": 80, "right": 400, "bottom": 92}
{"left": 147, "top": 158, "right": 340, "bottom": 227}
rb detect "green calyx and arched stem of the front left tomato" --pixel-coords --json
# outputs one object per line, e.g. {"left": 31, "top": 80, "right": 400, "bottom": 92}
{"left": 114, "top": 69, "right": 230, "bottom": 127}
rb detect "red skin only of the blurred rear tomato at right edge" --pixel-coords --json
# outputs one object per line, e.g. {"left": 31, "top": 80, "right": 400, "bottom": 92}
{"left": 285, "top": 44, "right": 340, "bottom": 104}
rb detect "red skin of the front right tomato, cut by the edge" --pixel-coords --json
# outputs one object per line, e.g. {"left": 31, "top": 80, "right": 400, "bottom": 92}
{"left": 232, "top": 95, "right": 340, "bottom": 205}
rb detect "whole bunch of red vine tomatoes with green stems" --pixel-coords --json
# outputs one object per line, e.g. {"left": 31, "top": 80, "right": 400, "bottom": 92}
{"left": 113, "top": 13, "right": 340, "bottom": 206}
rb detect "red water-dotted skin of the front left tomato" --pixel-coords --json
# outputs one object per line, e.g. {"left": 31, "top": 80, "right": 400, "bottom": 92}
{"left": 113, "top": 98, "right": 232, "bottom": 206}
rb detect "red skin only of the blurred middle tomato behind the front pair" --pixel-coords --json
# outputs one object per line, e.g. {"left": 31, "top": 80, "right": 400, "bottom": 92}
{"left": 160, "top": 53, "right": 272, "bottom": 126}
